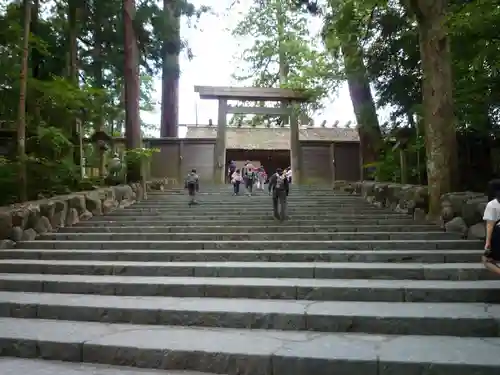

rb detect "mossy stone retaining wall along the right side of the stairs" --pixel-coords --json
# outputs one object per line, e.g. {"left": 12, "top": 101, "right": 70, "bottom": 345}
{"left": 334, "top": 181, "right": 488, "bottom": 239}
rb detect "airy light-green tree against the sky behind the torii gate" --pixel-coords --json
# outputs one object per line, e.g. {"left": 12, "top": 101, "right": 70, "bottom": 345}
{"left": 233, "top": 0, "right": 336, "bottom": 125}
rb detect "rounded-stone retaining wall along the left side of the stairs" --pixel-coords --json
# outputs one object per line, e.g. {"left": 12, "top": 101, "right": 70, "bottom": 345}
{"left": 0, "top": 180, "right": 170, "bottom": 249}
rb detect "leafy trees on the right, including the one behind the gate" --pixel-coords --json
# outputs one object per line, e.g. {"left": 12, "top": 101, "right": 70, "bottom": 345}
{"left": 232, "top": 0, "right": 500, "bottom": 214}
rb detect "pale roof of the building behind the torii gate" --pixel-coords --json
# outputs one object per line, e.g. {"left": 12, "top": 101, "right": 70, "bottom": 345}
{"left": 186, "top": 126, "right": 359, "bottom": 150}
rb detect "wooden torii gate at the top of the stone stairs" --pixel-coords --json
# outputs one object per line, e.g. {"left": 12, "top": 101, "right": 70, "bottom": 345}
{"left": 194, "top": 86, "right": 310, "bottom": 183}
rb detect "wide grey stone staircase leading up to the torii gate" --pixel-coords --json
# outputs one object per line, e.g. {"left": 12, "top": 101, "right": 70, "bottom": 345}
{"left": 0, "top": 187, "right": 500, "bottom": 375}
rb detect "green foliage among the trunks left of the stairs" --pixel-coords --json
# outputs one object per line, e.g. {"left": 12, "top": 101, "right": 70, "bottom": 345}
{"left": 0, "top": 0, "right": 210, "bottom": 205}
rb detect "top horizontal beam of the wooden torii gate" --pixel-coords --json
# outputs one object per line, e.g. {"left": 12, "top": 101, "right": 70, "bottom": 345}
{"left": 194, "top": 86, "right": 310, "bottom": 102}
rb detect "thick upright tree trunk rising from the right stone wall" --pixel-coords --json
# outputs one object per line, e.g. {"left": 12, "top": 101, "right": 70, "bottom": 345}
{"left": 410, "top": 0, "right": 458, "bottom": 217}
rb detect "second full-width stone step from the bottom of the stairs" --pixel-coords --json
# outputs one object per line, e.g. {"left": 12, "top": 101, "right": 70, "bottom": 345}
{"left": 0, "top": 292, "right": 500, "bottom": 338}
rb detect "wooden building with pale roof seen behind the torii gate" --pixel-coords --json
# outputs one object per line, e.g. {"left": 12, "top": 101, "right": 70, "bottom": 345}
{"left": 186, "top": 126, "right": 360, "bottom": 183}
